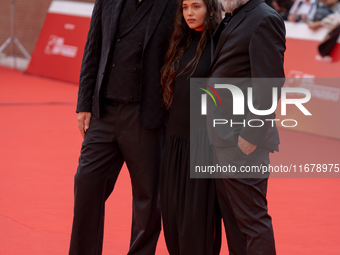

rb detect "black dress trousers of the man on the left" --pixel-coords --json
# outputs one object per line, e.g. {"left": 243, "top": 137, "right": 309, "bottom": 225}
{"left": 69, "top": 100, "right": 164, "bottom": 255}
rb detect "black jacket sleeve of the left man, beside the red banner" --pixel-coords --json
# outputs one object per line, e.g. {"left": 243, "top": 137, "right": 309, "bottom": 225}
{"left": 77, "top": 0, "right": 104, "bottom": 112}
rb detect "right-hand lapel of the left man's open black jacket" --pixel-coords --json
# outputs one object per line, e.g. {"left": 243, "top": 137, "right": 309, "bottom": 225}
{"left": 143, "top": 0, "right": 168, "bottom": 49}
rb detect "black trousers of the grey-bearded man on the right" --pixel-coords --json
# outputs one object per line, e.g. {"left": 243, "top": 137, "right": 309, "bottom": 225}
{"left": 214, "top": 145, "right": 276, "bottom": 255}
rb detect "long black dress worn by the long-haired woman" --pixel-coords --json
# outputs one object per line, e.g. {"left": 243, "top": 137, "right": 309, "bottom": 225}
{"left": 161, "top": 30, "right": 220, "bottom": 255}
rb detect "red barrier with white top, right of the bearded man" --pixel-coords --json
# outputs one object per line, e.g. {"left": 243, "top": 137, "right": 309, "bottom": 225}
{"left": 276, "top": 21, "right": 340, "bottom": 139}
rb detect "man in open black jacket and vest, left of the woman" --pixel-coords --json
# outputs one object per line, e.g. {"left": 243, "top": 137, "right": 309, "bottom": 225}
{"left": 69, "top": 0, "right": 177, "bottom": 255}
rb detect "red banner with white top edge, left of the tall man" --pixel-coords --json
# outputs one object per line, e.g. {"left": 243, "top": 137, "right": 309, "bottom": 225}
{"left": 26, "top": 1, "right": 93, "bottom": 83}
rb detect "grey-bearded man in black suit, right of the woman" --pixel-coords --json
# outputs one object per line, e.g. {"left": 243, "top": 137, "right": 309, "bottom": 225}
{"left": 208, "top": 0, "right": 285, "bottom": 255}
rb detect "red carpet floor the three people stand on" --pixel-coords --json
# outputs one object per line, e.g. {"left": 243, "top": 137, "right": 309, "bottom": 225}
{"left": 0, "top": 67, "right": 340, "bottom": 255}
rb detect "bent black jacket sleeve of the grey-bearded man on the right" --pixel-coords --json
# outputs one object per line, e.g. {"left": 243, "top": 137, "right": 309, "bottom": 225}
{"left": 240, "top": 15, "right": 286, "bottom": 146}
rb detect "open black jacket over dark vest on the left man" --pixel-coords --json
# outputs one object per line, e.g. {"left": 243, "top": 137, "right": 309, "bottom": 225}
{"left": 77, "top": 0, "right": 177, "bottom": 128}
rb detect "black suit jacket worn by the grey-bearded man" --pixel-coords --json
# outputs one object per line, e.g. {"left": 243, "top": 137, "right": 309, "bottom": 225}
{"left": 208, "top": 0, "right": 286, "bottom": 150}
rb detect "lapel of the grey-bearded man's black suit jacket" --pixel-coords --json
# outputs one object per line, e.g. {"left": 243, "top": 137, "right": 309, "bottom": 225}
{"left": 210, "top": 8, "right": 246, "bottom": 70}
